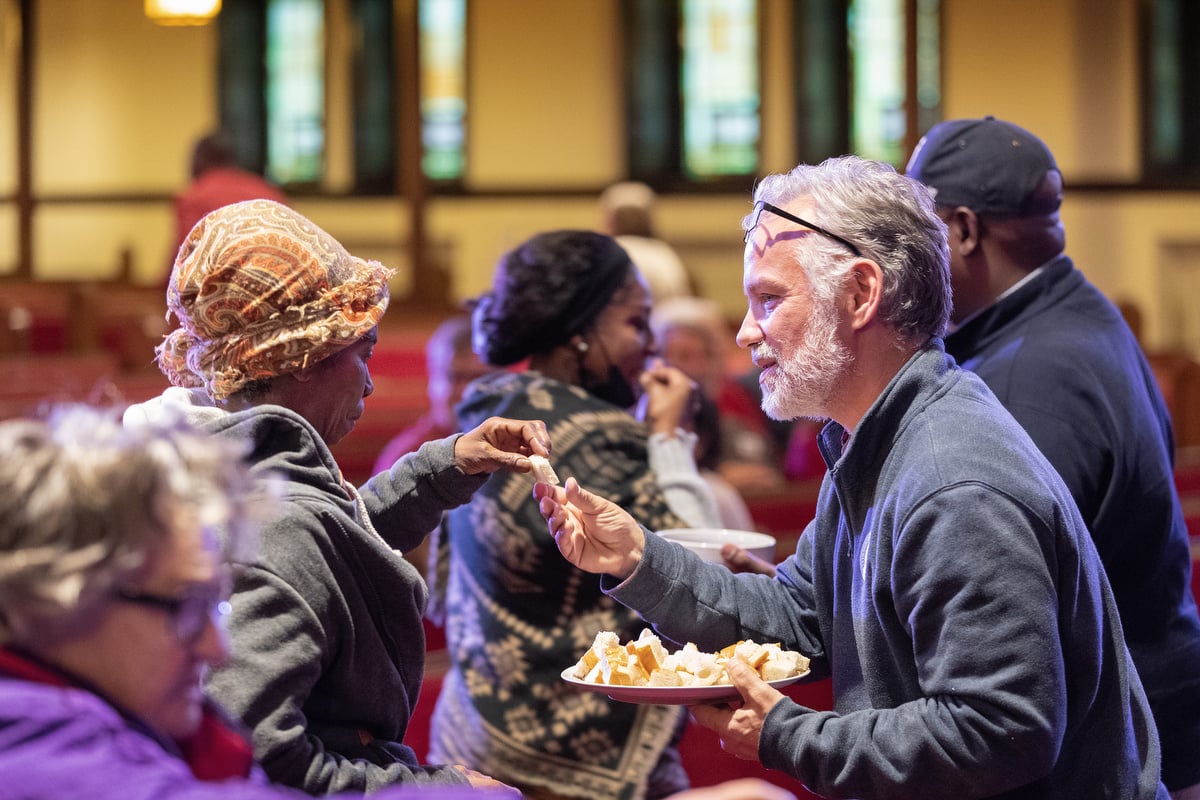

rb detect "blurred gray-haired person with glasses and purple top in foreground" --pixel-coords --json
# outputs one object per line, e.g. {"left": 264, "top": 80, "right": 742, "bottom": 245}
{"left": 0, "top": 407, "right": 290, "bottom": 798}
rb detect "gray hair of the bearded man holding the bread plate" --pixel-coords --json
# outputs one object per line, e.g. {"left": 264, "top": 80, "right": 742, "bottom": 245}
{"left": 743, "top": 156, "right": 950, "bottom": 343}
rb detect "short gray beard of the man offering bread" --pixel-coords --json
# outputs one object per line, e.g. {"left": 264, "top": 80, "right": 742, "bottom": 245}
{"left": 756, "top": 301, "right": 853, "bottom": 420}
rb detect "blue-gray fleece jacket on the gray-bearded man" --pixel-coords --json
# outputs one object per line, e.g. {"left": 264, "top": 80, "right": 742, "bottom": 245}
{"left": 604, "top": 339, "right": 1166, "bottom": 800}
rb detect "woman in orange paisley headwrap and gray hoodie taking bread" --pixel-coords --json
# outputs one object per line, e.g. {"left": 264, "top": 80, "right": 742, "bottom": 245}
{"left": 126, "top": 200, "right": 548, "bottom": 794}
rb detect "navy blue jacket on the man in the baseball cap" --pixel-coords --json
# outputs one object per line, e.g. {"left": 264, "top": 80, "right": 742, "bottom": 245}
{"left": 946, "top": 255, "right": 1200, "bottom": 789}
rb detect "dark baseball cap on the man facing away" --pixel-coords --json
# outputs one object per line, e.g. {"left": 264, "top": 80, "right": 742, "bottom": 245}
{"left": 905, "top": 116, "right": 1062, "bottom": 217}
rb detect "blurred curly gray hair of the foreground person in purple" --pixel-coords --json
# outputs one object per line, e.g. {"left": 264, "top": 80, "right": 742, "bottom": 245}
{"left": 0, "top": 405, "right": 270, "bottom": 644}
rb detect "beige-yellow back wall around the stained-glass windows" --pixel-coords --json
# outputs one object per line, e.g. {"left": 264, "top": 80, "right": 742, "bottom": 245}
{"left": 0, "top": 0, "right": 1200, "bottom": 347}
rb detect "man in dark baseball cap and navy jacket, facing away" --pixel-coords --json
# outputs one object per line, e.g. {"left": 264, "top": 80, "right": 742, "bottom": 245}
{"left": 907, "top": 116, "right": 1200, "bottom": 800}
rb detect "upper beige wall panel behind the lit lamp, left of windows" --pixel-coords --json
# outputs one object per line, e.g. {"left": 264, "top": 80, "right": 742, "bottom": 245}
{"left": 34, "top": 0, "right": 215, "bottom": 194}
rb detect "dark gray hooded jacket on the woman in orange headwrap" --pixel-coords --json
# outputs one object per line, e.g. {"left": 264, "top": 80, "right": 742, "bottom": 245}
{"left": 126, "top": 389, "right": 487, "bottom": 794}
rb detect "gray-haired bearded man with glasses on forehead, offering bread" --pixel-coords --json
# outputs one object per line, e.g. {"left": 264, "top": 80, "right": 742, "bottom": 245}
{"left": 534, "top": 156, "right": 1168, "bottom": 800}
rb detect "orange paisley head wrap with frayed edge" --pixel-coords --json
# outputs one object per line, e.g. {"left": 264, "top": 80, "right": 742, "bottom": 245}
{"left": 155, "top": 200, "right": 392, "bottom": 399}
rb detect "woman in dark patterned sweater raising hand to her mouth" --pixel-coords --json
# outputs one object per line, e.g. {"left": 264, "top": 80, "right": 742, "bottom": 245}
{"left": 430, "top": 230, "right": 718, "bottom": 800}
